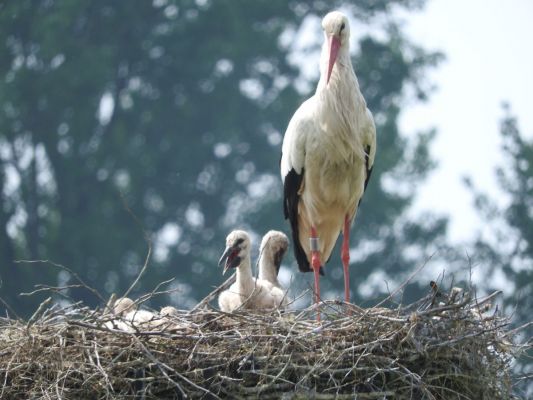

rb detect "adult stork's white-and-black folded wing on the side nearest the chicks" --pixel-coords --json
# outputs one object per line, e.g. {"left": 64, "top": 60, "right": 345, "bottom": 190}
{"left": 280, "top": 97, "right": 317, "bottom": 272}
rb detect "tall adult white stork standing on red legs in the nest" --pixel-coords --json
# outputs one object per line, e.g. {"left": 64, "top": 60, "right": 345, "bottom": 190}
{"left": 281, "top": 11, "right": 376, "bottom": 319}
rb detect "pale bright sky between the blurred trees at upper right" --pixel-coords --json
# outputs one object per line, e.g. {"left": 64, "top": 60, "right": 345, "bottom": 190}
{"left": 400, "top": 0, "right": 533, "bottom": 243}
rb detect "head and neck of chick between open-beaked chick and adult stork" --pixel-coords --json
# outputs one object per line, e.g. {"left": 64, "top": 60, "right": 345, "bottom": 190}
{"left": 259, "top": 230, "right": 289, "bottom": 289}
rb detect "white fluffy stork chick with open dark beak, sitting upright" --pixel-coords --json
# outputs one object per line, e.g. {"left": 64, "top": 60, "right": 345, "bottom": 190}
{"left": 218, "top": 230, "right": 285, "bottom": 312}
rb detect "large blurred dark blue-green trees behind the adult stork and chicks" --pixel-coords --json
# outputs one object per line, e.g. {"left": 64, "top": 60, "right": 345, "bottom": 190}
{"left": 0, "top": 0, "right": 446, "bottom": 315}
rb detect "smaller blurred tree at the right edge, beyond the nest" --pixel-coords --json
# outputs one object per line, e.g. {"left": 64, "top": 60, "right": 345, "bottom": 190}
{"left": 466, "top": 104, "right": 533, "bottom": 392}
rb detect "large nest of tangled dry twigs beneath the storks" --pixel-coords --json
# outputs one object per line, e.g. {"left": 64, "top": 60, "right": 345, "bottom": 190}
{"left": 0, "top": 287, "right": 517, "bottom": 399}
